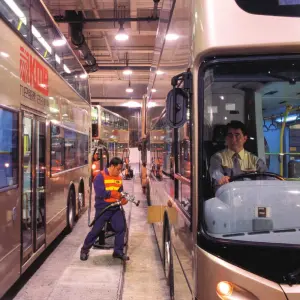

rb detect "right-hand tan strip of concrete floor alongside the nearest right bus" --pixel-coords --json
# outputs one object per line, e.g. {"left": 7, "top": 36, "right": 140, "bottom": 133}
{"left": 122, "top": 179, "right": 170, "bottom": 300}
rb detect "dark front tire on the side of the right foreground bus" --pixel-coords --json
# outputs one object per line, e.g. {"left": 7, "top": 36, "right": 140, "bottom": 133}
{"left": 163, "top": 217, "right": 175, "bottom": 299}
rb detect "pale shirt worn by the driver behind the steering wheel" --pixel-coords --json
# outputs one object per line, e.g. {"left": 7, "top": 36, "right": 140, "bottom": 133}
{"left": 209, "top": 148, "right": 268, "bottom": 181}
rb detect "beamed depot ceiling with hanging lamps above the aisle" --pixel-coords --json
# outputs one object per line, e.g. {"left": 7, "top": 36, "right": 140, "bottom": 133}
{"left": 45, "top": 0, "right": 164, "bottom": 106}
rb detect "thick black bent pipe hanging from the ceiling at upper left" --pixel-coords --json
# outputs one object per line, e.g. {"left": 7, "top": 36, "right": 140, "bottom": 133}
{"left": 66, "top": 11, "right": 97, "bottom": 71}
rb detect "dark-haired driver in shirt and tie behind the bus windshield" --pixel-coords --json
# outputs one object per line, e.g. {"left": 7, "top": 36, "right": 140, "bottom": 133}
{"left": 209, "top": 121, "right": 268, "bottom": 189}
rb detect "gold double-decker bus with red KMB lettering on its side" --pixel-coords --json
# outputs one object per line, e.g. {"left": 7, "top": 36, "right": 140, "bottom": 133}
{"left": 0, "top": 0, "right": 91, "bottom": 297}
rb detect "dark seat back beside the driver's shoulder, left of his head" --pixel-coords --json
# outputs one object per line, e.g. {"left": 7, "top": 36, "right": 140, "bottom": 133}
{"left": 202, "top": 124, "right": 227, "bottom": 199}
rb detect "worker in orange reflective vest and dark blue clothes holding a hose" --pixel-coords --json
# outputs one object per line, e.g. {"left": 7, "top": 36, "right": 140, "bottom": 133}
{"left": 80, "top": 157, "right": 129, "bottom": 260}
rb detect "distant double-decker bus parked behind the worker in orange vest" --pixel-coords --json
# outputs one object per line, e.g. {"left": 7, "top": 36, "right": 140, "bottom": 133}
{"left": 92, "top": 105, "right": 129, "bottom": 162}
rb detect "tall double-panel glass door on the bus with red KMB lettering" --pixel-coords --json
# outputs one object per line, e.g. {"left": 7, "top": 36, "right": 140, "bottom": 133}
{"left": 21, "top": 112, "right": 46, "bottom": 264}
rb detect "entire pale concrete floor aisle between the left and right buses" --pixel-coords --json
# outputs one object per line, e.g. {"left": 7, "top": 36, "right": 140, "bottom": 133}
{"left": 4, "top": 173, "right": 169, "bottom": 300}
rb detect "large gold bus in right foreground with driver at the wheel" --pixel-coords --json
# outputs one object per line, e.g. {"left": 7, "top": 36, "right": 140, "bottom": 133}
{"left": 147, "top": 0, "right": 300, "bottom": 300}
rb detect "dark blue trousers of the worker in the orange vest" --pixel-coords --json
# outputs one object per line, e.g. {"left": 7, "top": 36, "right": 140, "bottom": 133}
{"left": 82, "top": 208, "right": 126, "bottom": 254}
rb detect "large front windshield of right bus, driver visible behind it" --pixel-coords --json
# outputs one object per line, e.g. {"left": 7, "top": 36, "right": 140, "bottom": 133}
{"left": 201, "top": 56, "right": 300, "bottom": 244}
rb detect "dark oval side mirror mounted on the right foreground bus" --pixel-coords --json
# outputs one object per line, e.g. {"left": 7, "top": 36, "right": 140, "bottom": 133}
{"left": 166, "top": 88, "right": 188, "bottom": 128}
